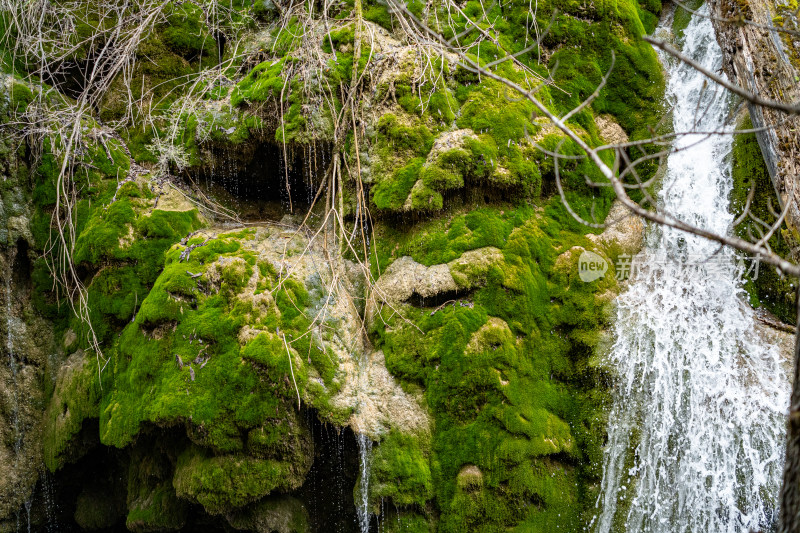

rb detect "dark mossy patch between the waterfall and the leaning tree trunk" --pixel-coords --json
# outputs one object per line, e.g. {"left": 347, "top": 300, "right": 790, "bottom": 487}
{"left": 730, "top": 116, "right": 797, "bottom": 324}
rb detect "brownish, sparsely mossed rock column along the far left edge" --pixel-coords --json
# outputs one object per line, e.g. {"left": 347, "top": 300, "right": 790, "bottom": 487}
{"left": 0, "top": 76, "right": 60, "bottom": 529}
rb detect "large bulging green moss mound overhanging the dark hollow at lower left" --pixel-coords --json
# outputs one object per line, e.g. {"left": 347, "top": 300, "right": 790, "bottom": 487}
{"left": 90, "top": 230, "right": 338, "bottom": 520}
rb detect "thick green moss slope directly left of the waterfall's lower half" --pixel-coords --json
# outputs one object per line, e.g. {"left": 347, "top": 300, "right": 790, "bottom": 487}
{"left": 372, "top": 204, "right": 615, "bottom": 531}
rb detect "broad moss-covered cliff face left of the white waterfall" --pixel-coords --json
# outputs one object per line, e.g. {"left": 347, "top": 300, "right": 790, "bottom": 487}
{"left": 0, "top": 1, "right": 663, "bottom": 533}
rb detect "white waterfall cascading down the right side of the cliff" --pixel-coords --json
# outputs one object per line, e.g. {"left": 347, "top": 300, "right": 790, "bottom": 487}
{"left": 593, "top": 7, "right": 789, "bottom": 533}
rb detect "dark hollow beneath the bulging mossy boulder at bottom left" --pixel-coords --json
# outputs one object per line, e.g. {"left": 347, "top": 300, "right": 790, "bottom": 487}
{"left": 14, "top": 410, "right": 378, "bottom": 533}
